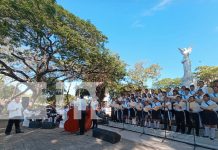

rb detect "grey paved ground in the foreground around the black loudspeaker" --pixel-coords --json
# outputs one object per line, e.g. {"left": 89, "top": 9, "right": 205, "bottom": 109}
{"left": 0, "top": 121, "right": 213, "bottom": 150}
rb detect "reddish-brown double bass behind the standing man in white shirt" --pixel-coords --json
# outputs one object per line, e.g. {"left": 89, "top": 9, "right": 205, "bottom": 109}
{"left": 64, "top": 107, "right": 92, "bottom": 133}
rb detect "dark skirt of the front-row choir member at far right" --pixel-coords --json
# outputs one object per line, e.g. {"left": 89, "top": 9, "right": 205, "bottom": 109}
{"left": 203, "top": 110, "right": 217, "bottom": 125}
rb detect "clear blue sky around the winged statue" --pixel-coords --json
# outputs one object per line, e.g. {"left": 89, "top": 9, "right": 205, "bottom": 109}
{"left": 57, "top": 0, "right": 218, "bottom": 78}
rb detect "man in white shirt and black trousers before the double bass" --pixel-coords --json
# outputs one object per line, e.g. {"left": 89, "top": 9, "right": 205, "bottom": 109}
{"left": 77, "top": 95, "right": 86, "bottom": 135}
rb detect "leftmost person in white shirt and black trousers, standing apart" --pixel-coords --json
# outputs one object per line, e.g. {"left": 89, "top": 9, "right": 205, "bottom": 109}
{"left": 5, "top": 97, "right": 23, "bottom": 135}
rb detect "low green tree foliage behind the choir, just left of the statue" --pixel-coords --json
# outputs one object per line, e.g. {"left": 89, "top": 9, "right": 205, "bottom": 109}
{"left": 153, "top": 78, "right": 182, "bottom": 89}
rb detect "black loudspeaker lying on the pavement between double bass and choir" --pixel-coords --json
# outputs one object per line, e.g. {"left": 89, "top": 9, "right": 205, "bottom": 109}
{"left": 92, "top": 128, "right": 121, "bottom": 144}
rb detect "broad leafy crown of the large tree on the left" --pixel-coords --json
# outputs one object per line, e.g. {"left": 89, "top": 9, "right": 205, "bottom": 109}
{"left": 0, "top": 0, "right": 126, "bottom": 100}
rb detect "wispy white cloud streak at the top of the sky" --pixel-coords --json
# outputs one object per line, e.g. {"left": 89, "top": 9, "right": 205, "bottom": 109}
{"left": 143, "top": 0, "right": 173, "bottom": 16}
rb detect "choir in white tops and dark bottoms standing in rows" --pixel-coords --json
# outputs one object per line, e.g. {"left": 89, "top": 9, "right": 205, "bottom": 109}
{"left": 110, "top": 81, "right": 218, "bottom": 140}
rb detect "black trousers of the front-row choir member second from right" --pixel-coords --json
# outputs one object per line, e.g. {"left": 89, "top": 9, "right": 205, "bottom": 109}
{"left": 188, "top": 113, "right": 200, "bottom": 136}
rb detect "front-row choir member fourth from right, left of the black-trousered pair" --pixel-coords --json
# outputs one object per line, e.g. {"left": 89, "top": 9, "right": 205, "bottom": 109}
{"left": 162, "top": 96, "right": 172, "bottom": 130}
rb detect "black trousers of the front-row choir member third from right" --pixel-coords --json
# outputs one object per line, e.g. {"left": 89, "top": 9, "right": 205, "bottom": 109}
{"left": 175, "top": 111, "right": 185, "bottom": 133}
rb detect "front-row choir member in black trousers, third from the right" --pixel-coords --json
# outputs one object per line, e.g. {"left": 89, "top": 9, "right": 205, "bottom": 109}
{"left": 173, "top": 95, "right": 186, "bottom": 134}
